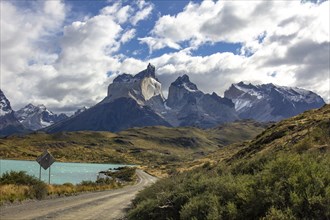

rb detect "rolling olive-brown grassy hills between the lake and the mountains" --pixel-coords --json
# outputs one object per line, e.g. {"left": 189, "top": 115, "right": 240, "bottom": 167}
{"left": 0, "top": 121, "right": 265, "bottom": 176}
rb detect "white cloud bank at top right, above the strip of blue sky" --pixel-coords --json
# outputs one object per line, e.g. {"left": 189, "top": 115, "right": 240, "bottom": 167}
{"left": 141, "top": 0, "right": 329, "bottom": 50}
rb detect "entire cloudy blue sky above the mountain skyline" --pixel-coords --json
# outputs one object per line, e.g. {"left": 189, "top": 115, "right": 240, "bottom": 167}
{"left": 0, "top": 0, "right": 330, "bottom": 113}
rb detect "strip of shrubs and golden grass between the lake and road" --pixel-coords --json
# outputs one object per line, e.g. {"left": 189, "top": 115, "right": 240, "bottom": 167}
{"left": 0, "top": 167, "right": 136, "bottom": 205}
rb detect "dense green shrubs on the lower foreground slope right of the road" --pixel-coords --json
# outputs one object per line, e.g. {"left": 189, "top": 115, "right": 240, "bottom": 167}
{"left": 128, "top": 152, "right": 330, "bottom": 219}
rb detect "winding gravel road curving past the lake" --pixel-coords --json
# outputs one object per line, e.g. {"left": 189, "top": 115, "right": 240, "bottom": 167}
{"left": 0, "top": 170, "right": 156, "bottom": 220}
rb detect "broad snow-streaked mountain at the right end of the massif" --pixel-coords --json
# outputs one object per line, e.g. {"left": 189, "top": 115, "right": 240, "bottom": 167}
{"left": 225, "top": 82, "right": 325, "bottom": 121}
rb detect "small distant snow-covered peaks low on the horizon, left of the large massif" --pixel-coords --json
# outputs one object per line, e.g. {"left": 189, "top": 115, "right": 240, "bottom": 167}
{"left": 15, "top": 104, "right": 68, "bottom": 130}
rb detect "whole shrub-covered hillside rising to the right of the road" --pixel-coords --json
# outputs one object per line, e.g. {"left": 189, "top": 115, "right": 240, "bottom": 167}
{"left": 128, "top": 105, "right": 330, "bottom": 219}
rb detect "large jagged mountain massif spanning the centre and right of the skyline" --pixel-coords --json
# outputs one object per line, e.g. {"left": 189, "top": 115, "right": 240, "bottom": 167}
{"left": 45, "top": 64, "right": 324, "bottom": 132}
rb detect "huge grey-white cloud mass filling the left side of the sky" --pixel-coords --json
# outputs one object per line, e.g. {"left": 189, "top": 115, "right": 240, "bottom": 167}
{"left": 1, "top": 1, "right": 152, "bottom": 111}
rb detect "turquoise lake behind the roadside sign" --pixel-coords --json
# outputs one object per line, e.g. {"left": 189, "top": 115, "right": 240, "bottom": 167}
{"left": 0, "top": 159, "right": 129, "bottom": 184}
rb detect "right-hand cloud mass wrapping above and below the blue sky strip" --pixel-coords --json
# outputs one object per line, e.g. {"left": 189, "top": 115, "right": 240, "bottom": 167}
{"left": 139, "top": 1, "right": 330, "bottom": 102}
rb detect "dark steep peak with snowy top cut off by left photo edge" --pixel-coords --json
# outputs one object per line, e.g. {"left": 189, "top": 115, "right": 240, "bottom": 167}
{"left": 0, "top": 90, "right": 27, "bottom": 136}
